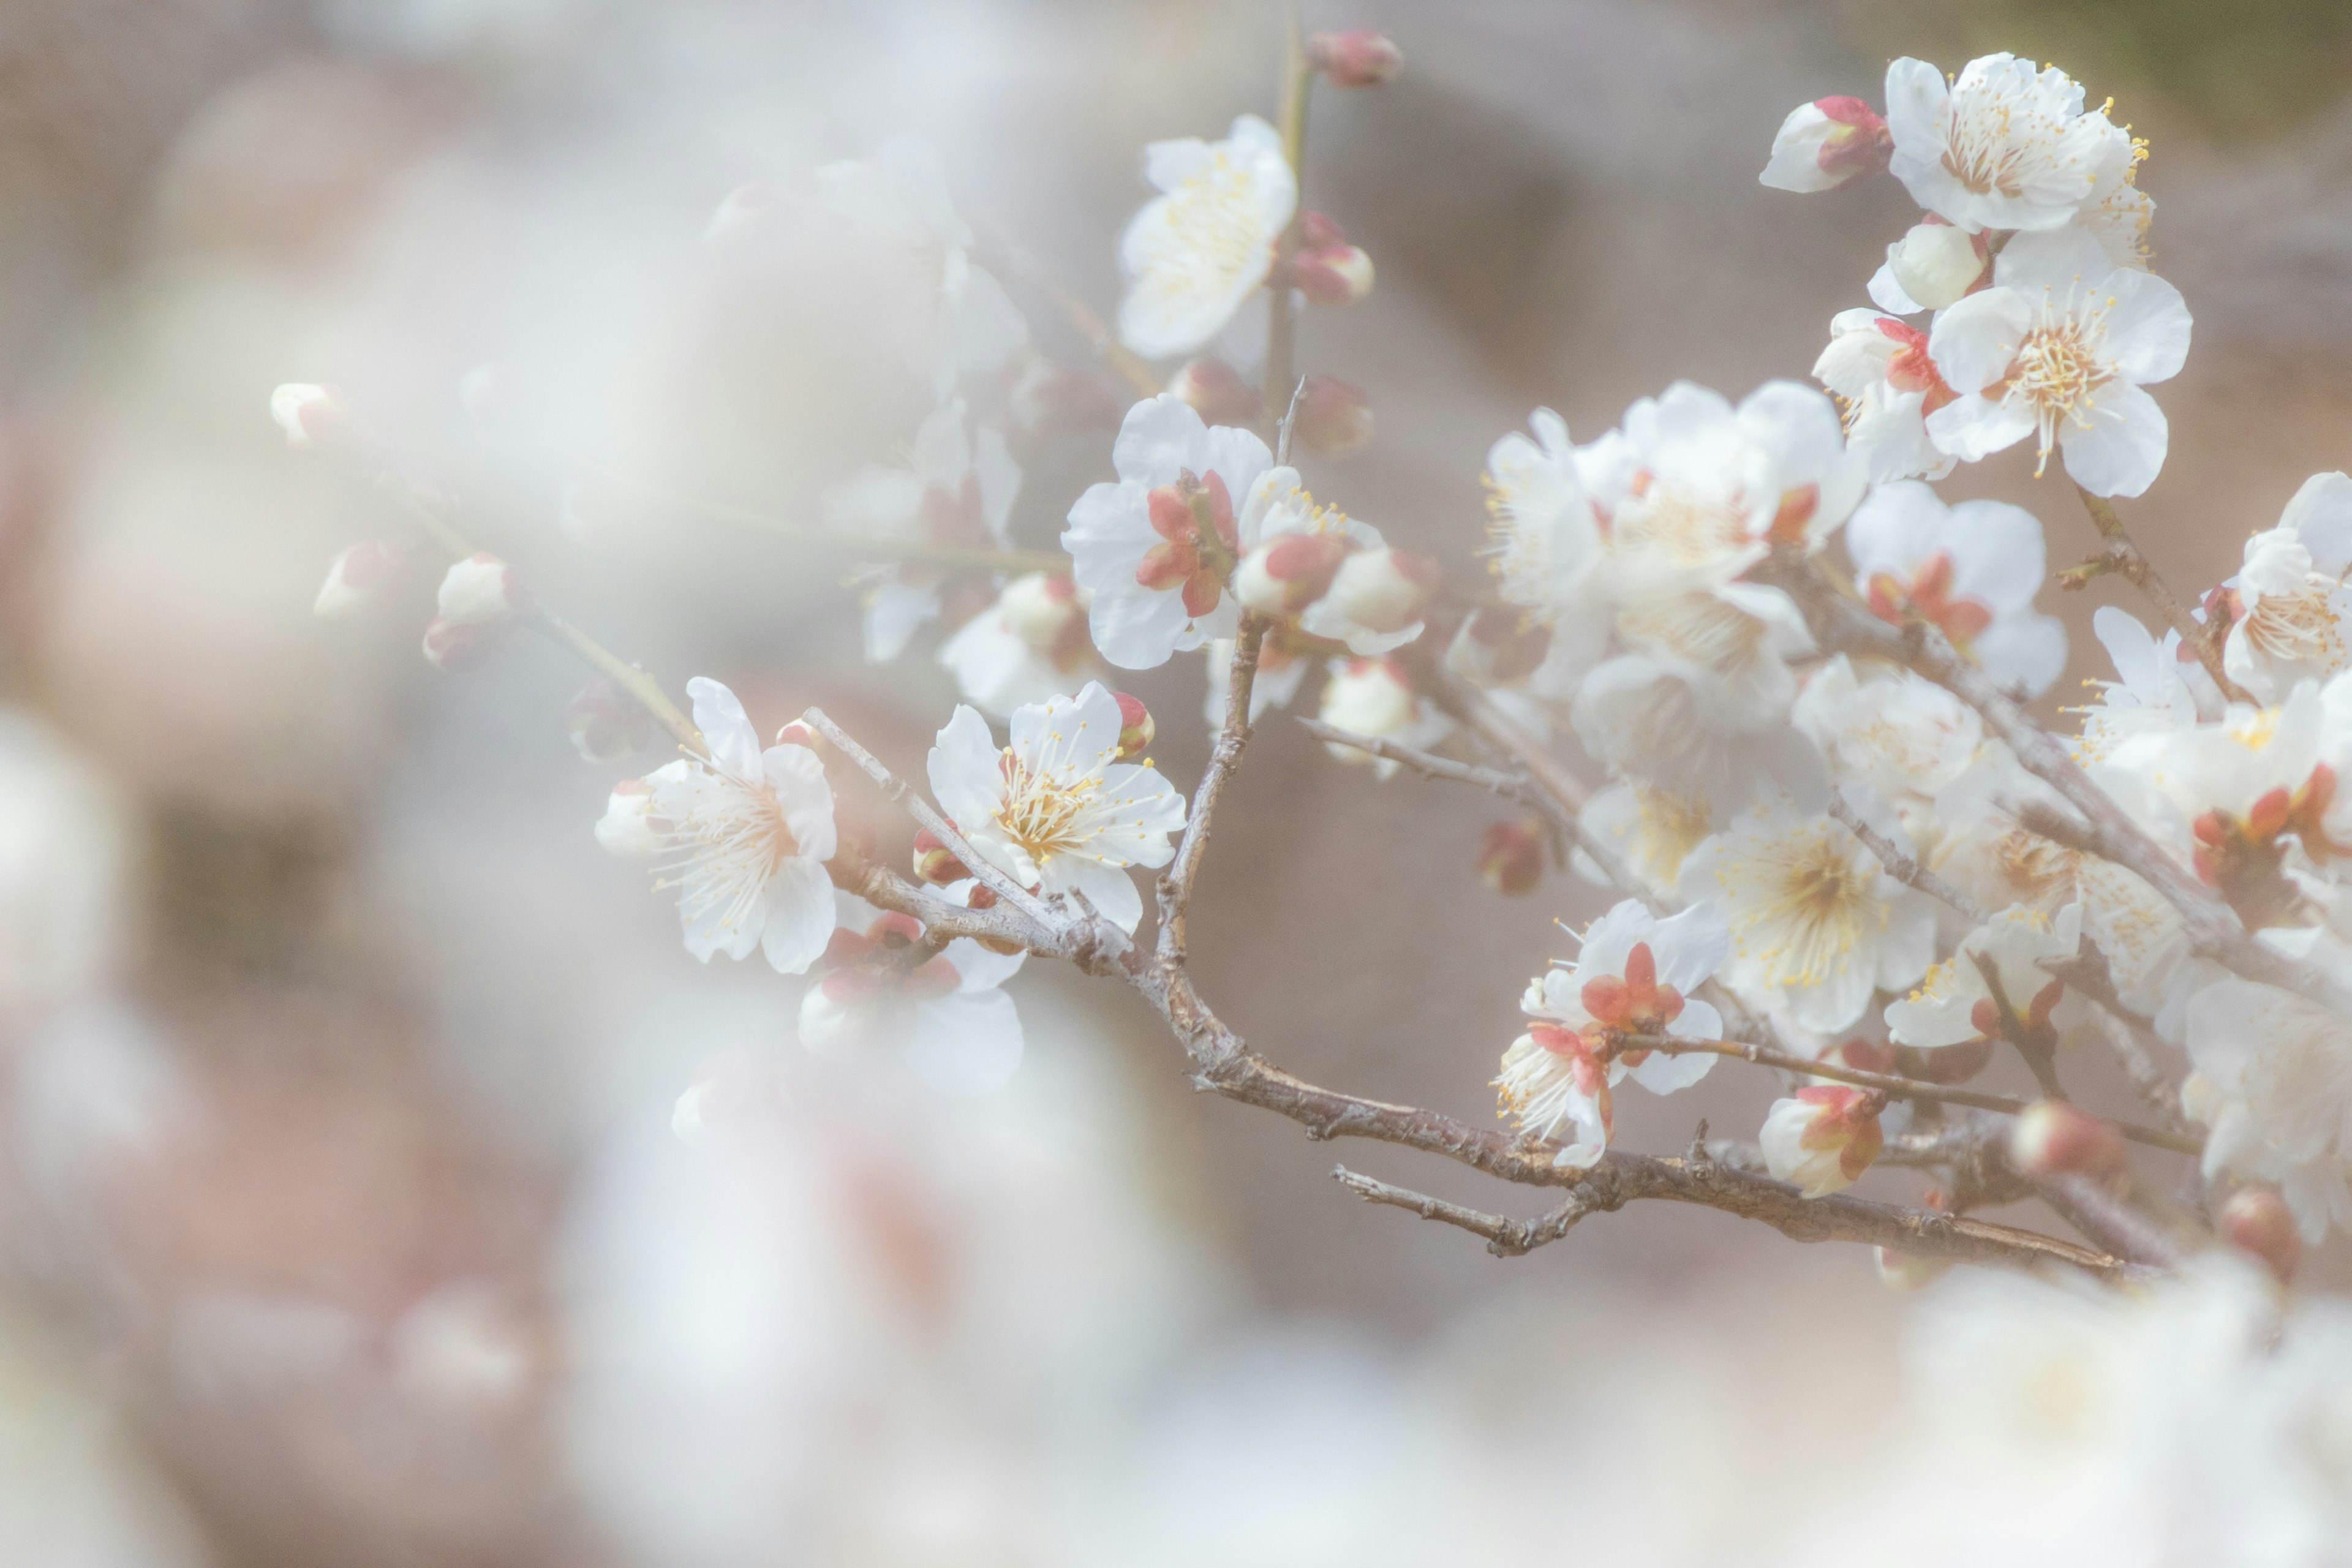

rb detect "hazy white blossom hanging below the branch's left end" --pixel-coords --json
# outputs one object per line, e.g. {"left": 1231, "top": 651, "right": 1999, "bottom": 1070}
{"left": 800, "top": 891, "right": 1028, "bottom": 1096}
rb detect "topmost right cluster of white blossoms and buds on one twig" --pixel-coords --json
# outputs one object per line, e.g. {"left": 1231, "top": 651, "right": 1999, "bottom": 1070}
{"left": 1762, "top": 54, "right": 2190, "bottom": 496}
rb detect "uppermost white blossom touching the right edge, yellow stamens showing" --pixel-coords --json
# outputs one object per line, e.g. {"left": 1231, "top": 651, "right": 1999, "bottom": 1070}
{"left": 2220, "top": 472, "right": 2352, "bottom": 703}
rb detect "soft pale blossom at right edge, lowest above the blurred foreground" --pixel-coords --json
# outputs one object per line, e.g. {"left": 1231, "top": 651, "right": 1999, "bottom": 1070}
{"left": 2180, "top": 976, "right": 2352, "bottom": 1243}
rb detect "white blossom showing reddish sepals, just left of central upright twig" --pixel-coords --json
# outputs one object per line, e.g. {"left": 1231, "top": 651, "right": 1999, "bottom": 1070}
{"left": 1061, "top": 393, "right": 1275, "bottom": 670}
